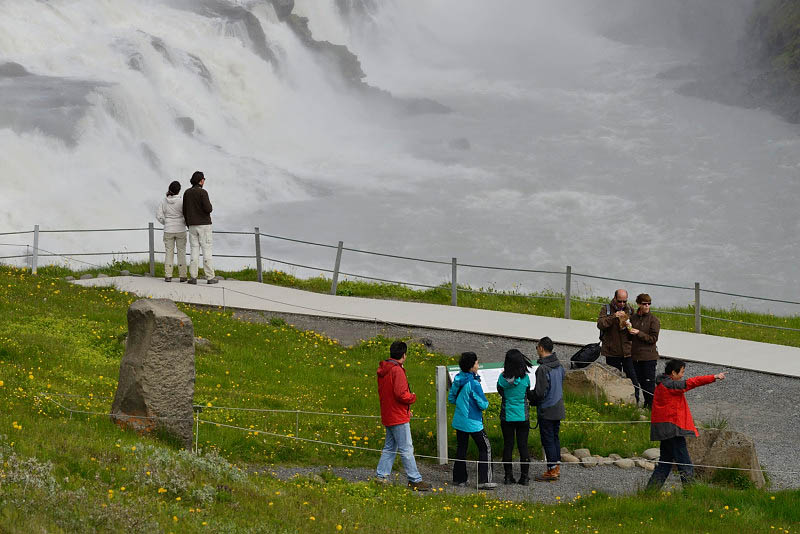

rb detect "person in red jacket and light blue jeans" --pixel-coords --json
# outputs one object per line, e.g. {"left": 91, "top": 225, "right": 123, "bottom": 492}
{"left": 376, "top": 341, "right": 431, "bottom": 491}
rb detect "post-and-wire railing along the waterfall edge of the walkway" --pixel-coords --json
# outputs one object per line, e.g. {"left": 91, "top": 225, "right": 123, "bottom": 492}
{"left": 0, "top": 222, "right": 800, "bottom": 333}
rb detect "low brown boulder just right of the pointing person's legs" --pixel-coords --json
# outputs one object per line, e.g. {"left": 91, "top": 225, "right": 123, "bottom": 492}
{"left": 686, "top": 428, "right": 765, "bottom": 488}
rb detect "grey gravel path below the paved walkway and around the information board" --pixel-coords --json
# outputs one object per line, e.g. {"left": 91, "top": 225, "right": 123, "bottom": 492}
{"left": 231, "top": 311, "right": 800, "bottom": 494}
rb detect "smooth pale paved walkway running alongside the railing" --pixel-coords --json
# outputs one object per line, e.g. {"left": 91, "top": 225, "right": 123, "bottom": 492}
{"left": 75, "top": 276, "right": 800, "bottom": 377}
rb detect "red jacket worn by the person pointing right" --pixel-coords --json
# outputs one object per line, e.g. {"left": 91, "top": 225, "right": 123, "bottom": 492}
{"left": 650, "top": 374, "right": 716, "bottom": 441}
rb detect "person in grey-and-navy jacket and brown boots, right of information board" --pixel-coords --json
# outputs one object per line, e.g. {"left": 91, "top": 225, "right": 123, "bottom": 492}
{"left": 530, "top": 337, "right": 566, "bottom": 482}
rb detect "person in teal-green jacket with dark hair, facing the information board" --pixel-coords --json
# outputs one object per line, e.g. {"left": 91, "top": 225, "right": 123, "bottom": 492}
{"left": 497, "top": 349, "right": 533, "bottom": 486}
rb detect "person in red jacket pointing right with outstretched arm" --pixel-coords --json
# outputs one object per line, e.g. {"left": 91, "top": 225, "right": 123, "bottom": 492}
{"left": 647, "top": 360, "right": 725, "bottom": 491}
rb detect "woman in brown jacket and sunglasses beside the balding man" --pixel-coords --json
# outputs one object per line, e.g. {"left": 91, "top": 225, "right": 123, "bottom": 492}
{"left": 630, "top": 293, "right": 661, "bottom": 408}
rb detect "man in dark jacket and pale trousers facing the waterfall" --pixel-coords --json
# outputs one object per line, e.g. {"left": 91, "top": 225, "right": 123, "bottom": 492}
{"left": 183, "top": 171, "right": 217, "bottom": 284}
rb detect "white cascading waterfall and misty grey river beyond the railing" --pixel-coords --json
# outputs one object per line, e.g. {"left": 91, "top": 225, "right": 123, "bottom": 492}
{"left": 0, "top": 0, "right": 800, "bottom": 312}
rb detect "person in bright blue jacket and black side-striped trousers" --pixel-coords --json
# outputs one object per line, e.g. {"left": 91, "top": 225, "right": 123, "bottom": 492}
{"left": 447, "top": 352, "right": 497, "bottom": 489}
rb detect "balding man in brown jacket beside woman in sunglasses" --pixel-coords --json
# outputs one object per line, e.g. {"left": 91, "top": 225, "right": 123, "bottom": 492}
{"left": 597, "top": 289, "right": 639, "bottom": 404}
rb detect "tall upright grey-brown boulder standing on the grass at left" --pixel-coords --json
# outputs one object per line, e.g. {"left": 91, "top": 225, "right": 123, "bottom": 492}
{"left": 111, "top": 299, "right": 195, "bottom": 448}
